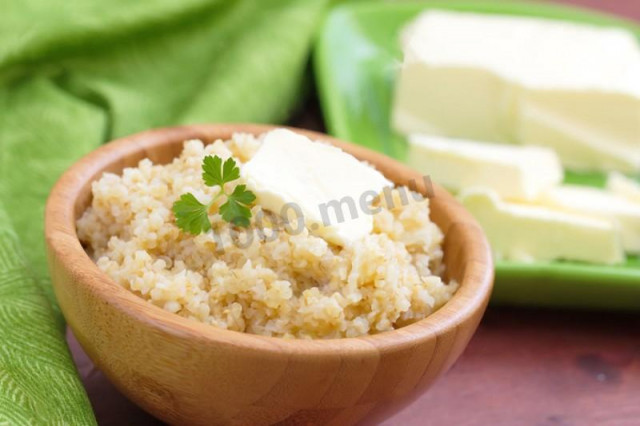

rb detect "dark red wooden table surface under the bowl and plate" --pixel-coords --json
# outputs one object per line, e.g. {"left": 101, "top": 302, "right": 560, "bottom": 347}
{"left": 69, "top": 0, "right": 640, "bottom": 426}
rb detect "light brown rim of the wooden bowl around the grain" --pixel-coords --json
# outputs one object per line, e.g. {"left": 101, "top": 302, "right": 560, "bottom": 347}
{"left": 45, "top": 123, "right": 494, "bottom": 357}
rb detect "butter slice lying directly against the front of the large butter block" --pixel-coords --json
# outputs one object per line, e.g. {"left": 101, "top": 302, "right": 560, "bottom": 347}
{"left": 407, "top": 134, "right": 563, "bottom": 200}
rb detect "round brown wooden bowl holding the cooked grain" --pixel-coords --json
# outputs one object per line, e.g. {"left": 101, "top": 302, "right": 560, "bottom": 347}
{"left": 45, "top": 124, "right": 493, "bottom": 425}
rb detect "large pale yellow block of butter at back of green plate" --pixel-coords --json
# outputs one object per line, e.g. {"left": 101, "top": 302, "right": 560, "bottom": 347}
{"left": 393, "top": 11, "right": 640, "bottom": 172}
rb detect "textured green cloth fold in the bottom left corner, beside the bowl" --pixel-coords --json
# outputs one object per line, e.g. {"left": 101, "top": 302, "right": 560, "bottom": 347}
{"left": 0, "top": 205, "right": 95, "bottom": 425}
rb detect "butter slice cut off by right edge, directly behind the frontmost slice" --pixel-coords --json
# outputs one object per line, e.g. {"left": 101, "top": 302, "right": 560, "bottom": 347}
{"left": 540, "top": 185, "right": 640, "bottom": 253}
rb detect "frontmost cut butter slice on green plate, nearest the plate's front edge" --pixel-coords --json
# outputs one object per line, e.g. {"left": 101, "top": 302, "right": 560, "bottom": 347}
{"left": 460, "top": 189, "right": 624, "bottom": 264}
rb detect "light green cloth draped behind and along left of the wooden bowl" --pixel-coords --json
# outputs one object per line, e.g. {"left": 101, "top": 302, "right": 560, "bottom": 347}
{"left": 0, "top": 0, "right": 327, "bottom": 423}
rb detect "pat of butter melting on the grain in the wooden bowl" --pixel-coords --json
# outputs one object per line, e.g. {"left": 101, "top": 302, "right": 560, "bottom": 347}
{"left": 241, "top": 129, "right": 393, "bottom": 246}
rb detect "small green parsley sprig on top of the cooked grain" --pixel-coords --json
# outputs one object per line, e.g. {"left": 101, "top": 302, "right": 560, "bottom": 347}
{"left": 172, "top": 155, "right": 256, "bottom": 235}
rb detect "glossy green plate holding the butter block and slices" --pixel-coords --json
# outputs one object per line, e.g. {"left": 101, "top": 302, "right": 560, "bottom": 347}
{"left": 314, "top": 0, "right": 640, "bottom": 309}
